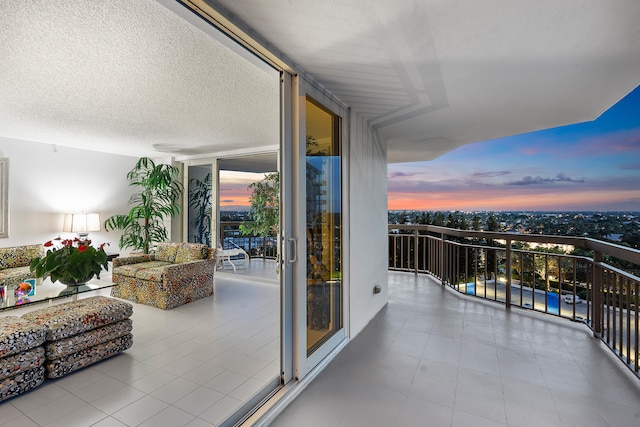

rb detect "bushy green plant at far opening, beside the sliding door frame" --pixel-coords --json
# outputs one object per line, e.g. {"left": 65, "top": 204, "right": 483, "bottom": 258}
{"left": 240, "top": 172, "right": 280, "bottom": 236}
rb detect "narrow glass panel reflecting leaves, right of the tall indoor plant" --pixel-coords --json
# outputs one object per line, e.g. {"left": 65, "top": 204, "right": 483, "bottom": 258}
{"left": 188, "top": 165, "right": 213, "bottom": 246}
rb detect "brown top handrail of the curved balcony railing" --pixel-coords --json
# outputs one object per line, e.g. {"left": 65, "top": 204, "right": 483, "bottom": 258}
{"left": 387, "top": 224, "right": 640, "bottom": 265}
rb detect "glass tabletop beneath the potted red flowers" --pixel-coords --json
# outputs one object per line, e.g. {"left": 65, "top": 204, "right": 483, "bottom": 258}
{"left": 0, "top": 278, "right": 114, "bottom": 311}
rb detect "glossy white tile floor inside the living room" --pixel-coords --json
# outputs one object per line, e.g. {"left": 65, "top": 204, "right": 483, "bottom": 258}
{"left": 0, "top": 260, "right": 280, "bottom": 427}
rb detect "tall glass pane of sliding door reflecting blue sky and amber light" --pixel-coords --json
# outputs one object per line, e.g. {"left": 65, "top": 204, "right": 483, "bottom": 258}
{"left": 305, "top": 98, "right": 342, "bottom": 355}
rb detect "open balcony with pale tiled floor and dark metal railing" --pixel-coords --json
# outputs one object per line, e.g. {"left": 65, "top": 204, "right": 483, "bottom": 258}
{"left": 271, "top": 226, "right": 640, "bottom": 427}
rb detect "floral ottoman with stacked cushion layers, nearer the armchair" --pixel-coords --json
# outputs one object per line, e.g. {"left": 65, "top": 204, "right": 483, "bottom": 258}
{"left": 22, "top": 297, "right": 133, "bottom": 378}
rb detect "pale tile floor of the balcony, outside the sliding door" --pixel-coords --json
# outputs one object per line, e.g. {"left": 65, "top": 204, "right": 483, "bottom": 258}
{"left": 271, "top": 272, "right": 640, "bottom": 427}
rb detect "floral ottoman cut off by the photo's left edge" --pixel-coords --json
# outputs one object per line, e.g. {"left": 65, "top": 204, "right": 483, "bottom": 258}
{"left": 0, "top": 316, "right": 46, "bottom": 402}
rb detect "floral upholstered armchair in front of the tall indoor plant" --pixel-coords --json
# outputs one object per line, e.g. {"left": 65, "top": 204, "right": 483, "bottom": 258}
{"left": 111, "top": 242, "right": 216, "bottom": 310}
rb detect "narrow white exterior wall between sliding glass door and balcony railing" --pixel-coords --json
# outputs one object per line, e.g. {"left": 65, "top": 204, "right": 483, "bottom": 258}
{"left": 349, "top": 113, "right": 388, "bottom": 338}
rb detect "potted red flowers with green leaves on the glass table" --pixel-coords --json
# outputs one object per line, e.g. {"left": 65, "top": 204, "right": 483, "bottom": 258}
{"left": 29, "top": 237, "right": 108, "bottom": 285}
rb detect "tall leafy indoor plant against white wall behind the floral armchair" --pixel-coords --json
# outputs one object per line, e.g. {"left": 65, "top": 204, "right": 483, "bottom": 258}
{"left": 104, "top": 157, "right": 182, "bottom": 254}
